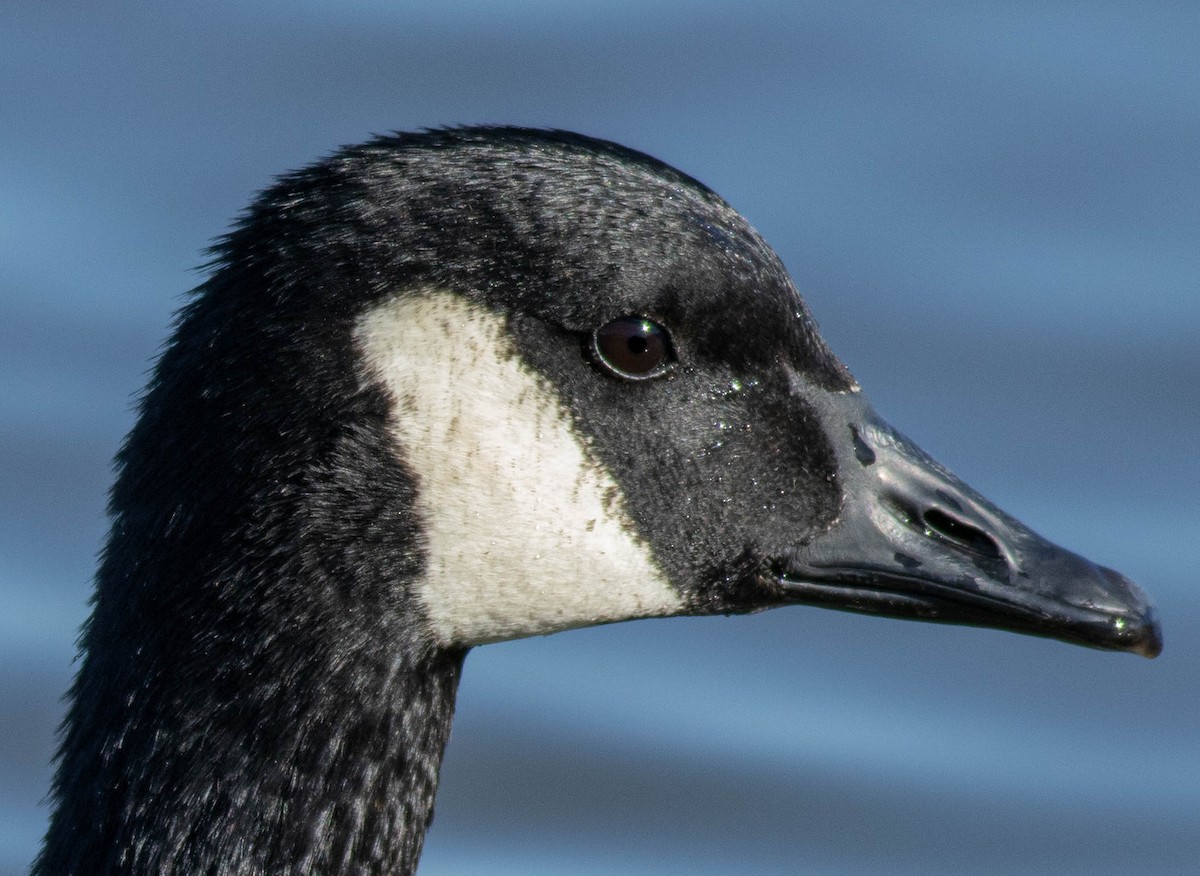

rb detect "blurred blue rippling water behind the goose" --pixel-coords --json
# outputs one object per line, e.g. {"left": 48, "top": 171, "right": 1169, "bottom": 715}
{"left": 0, "top": 0, "right": 1200, "bottom": 876}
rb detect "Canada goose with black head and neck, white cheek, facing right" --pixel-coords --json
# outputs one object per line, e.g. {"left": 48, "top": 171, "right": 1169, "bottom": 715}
{"left": 39, "top": 127, "right": 1162, "bottom": 876}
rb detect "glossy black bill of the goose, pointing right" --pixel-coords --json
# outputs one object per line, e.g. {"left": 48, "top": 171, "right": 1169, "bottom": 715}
{"left": 775, "top": 386, "right": 1163, "bottom": 658}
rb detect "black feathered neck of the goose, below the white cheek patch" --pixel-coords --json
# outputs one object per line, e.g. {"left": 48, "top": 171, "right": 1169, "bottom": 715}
{"left": 34, "top": 633, "right": 462, "bottom": 876}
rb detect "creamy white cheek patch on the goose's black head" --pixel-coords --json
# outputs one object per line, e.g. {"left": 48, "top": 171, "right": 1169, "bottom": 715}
{"left": 356, "top": 293, "right": 683, "bottom": 646}
